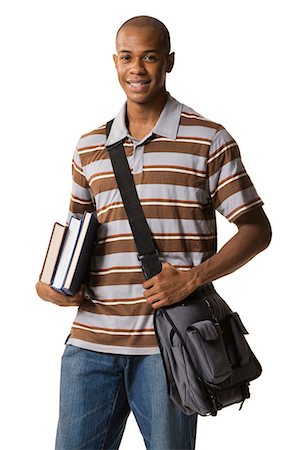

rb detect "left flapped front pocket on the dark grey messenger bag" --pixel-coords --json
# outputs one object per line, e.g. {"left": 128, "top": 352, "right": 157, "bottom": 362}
{"left": 186, "top": 320, "right": 232, "bottom": 384}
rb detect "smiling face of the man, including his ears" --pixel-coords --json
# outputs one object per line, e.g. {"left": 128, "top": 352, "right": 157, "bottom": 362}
{"left": 113, "top": 25, "right": 174, "bottom": 106}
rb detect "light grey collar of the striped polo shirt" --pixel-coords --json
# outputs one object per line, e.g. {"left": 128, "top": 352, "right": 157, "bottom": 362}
{"left": 106, "top": 95, "right": 183, "bottom": 146}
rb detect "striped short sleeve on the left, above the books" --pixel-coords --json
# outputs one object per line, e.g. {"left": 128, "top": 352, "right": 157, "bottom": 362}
{"left": 67, "top": 148, "right": 95, "bottom": 221}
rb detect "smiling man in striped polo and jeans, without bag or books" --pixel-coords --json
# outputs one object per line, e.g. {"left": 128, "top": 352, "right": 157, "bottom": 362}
{"left": 36, "top": 16, "right": 271, "bottom": 450}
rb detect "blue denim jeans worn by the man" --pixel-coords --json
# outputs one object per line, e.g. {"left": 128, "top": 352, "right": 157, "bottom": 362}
{"left": 55, "top": 345, "right": 197, "bottom": 450}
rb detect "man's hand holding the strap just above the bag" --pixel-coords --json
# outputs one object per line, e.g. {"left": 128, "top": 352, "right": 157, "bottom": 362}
{"left": 143, "top": 263, "right": 197, "bottom": 309}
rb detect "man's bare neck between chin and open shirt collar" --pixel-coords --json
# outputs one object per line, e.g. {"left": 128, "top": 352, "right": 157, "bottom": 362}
{"left": 127, "top": 92, "right": 168, "bottom": 139}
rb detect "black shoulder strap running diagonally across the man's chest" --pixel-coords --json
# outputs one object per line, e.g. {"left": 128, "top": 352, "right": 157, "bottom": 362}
{"left": 106, "top": 120, "right": 162, "bottom": 279}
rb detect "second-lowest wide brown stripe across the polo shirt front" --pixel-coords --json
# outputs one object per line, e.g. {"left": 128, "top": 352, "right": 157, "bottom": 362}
{"left": 80, "top": 299, "right": 153, "bottom": 317}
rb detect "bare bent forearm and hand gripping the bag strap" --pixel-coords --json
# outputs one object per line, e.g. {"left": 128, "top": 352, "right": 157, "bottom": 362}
{"left": 143, "top": 208, "right": 271, "bottom": 309}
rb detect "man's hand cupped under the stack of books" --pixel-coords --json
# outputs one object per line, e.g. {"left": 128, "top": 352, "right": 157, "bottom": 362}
{"left": 35, "top": 281, "right": 84, "bottom": 306}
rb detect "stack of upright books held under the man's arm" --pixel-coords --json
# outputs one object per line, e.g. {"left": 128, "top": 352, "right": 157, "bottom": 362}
{"left": 40, "top": 212, "right": 99, "bottom": 295}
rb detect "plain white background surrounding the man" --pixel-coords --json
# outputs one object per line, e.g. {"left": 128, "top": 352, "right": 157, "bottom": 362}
{"left": 0, "top": 0, "right": 299, "bottom": 450}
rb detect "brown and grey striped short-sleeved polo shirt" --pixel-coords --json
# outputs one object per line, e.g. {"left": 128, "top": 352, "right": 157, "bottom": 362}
{"left": 67, "top": 95, "right": 262, "bottom": 355}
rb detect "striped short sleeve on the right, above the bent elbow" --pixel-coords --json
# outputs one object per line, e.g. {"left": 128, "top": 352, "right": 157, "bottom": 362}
{"left": 207, "top": 128, "right": 263, "bottom": 222}
